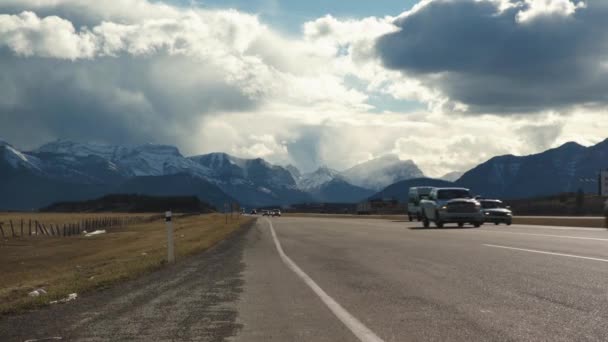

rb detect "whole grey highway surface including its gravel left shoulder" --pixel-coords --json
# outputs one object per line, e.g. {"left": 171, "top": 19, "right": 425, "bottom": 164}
{"left": 0, "top": 217, "right": 608, "bottom": 342}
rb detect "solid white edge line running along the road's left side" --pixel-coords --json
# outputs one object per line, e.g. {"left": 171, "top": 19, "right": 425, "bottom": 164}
{"left": 266, "top": 219, "right": 384, "bottom": 342}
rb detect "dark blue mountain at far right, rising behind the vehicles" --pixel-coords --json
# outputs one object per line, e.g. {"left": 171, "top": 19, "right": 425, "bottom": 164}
{"left": 457, "top": 140, "right": 608, "bottom": 198}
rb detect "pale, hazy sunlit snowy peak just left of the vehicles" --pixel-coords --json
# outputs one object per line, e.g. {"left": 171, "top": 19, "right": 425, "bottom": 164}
{"left": 341, "top": 154, "right": 424, "bottom": 190}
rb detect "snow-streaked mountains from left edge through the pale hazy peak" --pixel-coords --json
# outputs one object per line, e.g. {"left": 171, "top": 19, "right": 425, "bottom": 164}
{"left": 0, "top": 140, "right": 420, "bottom": 210}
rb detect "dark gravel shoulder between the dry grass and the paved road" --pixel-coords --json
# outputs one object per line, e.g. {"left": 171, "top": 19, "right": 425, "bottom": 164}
{"left": 0, "top": 220, "right": 251, "bottom": 341}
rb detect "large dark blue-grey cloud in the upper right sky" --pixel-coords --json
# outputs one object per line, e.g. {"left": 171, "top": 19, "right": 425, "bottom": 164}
{"left": 376, "top": 0, "right": 608, "bottom": 114}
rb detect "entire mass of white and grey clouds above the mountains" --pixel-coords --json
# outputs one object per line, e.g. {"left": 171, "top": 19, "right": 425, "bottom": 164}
{"left": 0, "top": 0, "right": 608, "bottom": 176}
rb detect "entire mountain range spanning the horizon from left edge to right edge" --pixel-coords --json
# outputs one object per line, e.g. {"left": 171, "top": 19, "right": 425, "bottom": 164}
{"left": 0, "top": 139, "right": 608, "bottom": 210}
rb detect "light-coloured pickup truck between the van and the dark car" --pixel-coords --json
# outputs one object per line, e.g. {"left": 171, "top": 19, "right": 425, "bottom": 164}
{"left": 420, "top": 188, "right": 484, "bottom": 228}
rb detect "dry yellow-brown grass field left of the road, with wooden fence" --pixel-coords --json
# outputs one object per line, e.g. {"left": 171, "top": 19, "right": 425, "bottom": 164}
{"left": 0, "top": 213, "right": 254, "bottom": 315}
